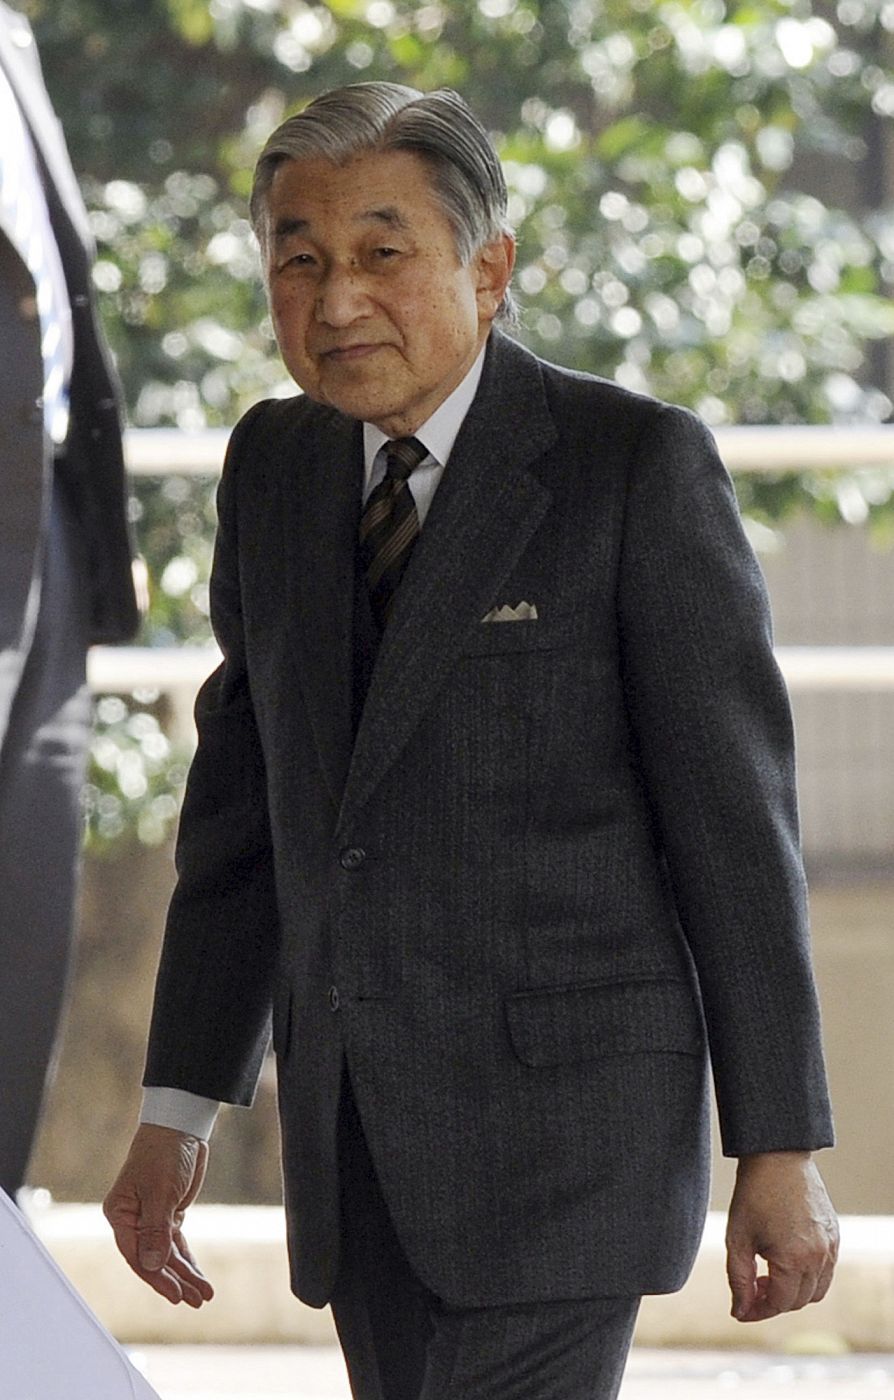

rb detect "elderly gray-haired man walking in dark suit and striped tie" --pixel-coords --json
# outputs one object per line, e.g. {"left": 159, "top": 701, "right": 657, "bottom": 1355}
{"left": 106, "top": 83, "right": 835, "bottom": 1400}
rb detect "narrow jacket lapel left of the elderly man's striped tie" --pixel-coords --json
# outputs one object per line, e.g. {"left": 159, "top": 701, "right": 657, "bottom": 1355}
{"left": 276, "top": 413, "right": 362, "bottom": 811}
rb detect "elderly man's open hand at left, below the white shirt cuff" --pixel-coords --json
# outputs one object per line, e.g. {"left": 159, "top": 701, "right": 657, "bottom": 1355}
{"left": 102, "top": 1123, "right": 214, "bottom": 1308}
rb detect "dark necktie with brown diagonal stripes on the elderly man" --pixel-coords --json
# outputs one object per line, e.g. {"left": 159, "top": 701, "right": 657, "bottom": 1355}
{"left": 360, "top": 438, "right": 428, "bottom": 630}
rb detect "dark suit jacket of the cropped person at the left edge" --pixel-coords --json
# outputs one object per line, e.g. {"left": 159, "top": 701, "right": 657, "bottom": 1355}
{"left": 0, "top": 3, "right": 139, "bottom": 736}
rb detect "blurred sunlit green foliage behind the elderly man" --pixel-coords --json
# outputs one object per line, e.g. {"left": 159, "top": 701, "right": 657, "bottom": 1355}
{"left": 22, "top": 0, "right": 894, "bottom": 834}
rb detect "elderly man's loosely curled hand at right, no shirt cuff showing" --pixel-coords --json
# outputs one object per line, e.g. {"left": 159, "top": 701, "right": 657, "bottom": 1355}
{"left": 726, "top": 1152, "right": 838, "bottom": 1322}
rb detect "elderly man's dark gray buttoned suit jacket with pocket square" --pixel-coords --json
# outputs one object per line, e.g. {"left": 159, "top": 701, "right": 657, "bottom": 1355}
{"left": 147, "top": 332, "right": 831, "bottom": 1305}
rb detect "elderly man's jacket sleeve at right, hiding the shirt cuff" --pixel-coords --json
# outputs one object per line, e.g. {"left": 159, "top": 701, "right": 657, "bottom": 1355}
{"left": 618, "top": 409, "right": 832, "bottom": 1156}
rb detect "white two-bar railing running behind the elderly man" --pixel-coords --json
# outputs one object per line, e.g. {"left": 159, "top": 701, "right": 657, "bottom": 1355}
{"left": 88, "top": 426, "right": 894, "bottom": 716}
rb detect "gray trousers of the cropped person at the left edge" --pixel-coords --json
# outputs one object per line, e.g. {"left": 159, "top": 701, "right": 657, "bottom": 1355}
{"left": 0, "top": 486, "right": 90, "bottom": 1197}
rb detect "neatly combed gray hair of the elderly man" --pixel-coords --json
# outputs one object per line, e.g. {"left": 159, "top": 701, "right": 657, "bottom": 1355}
{"left": 250, "top": 83, "right": 516, "bottom": 325}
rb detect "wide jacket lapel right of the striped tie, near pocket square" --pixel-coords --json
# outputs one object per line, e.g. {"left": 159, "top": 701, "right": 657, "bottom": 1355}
{"left": 340, "top": 332, "right": 555, "bottom": 826}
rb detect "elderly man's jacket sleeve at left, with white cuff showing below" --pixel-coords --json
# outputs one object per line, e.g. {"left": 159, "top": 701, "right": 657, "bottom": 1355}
{"left": 144, "top": 405, "right": 280, "bottom": 1103}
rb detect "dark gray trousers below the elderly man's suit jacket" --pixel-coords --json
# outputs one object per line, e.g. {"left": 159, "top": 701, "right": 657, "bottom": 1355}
{"left": 332, "top": 1072, "right": 639, "bottom": 1400}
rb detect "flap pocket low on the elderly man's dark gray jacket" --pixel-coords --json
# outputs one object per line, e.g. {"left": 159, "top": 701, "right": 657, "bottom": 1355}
{"left": 505, "top": 977, "right": 704, "bottom": 1065}
